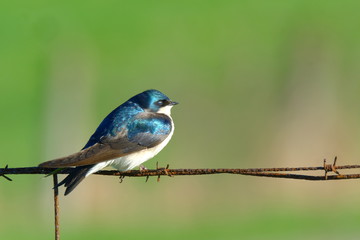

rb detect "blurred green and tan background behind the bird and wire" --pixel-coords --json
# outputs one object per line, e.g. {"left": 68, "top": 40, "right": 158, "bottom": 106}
{"left": 0, "top": 0, "right": 360, "bottom": 240}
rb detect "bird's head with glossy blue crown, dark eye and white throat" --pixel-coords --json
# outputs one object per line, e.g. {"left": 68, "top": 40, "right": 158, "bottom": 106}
{"left": 130, "top": 89, "right": 178, "bottom": 115}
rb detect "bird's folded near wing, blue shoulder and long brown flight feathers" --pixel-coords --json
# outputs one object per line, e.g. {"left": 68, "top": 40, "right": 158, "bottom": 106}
{"left": 40, "top": 112, "right": 172, "bottom": 168}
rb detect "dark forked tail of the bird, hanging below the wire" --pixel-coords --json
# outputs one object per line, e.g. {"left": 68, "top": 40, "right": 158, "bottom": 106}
{"left": 55, "top": 165, "right": 94, "bottom": 196}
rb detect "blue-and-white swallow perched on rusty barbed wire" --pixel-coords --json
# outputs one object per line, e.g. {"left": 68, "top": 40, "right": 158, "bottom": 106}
{"left": 39, "top": 89, "right": 178, "bottom": 196}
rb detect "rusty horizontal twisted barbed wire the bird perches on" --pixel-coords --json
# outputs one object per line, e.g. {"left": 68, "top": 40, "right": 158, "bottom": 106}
{"left": 0, "top": 157, "right": 360, "bottom": 181}
